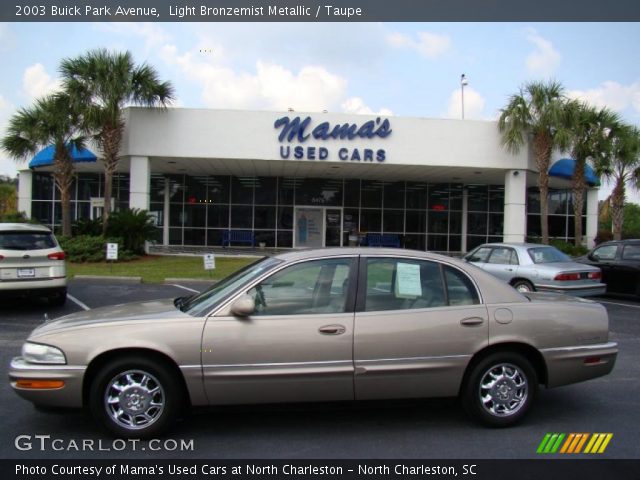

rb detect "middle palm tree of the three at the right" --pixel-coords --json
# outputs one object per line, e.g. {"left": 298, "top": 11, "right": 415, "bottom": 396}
{"left": 567, "top": 100, "right": 620, "bottom": 247}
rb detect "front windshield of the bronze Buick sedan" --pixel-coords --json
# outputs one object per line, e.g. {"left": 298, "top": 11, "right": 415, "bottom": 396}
{"left": 175, "top": 257, "right": 282, "bottom": 317}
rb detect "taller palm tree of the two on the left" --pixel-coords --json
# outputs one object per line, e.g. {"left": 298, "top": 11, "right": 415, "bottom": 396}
{"left": 60, "top": 49, "right": 174, "bottom": 232}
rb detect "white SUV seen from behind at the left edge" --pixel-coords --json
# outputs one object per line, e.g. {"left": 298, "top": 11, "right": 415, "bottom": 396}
{"left": 0, "top": 223, "right": 67, "bottom": 306}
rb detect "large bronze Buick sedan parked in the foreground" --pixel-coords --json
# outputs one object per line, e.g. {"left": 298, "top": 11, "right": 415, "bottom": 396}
{"left": 9, "top": 248, "right": 618, "bottom": 437}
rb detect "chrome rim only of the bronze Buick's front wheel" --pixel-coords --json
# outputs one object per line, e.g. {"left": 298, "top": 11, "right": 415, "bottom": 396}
{"left": 104, "top": 370, "right": 166, "bottom": 430}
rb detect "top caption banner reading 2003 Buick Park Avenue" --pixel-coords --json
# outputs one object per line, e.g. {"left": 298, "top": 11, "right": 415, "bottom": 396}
{"left": 0, "top": 0, "right": 640, "bottom": 22}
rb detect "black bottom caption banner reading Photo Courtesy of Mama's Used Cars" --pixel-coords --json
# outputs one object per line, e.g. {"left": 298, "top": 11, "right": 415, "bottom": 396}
{"left": 0, "top": 460, "right": 640, "bottom": 480}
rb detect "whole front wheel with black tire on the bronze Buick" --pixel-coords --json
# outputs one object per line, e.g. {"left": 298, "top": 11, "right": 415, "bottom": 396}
{"left": 89, "top": 356, "right": 183, "bottom": 438}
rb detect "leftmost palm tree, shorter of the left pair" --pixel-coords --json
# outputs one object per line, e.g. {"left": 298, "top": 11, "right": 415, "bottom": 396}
{"left": 2, "top": 93, "right": 85, "bottom": 235}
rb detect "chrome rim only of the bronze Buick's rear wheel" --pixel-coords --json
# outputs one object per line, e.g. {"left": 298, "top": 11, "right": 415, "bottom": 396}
{"left": 478, "top": 363, "right": 529, "bottom": 417}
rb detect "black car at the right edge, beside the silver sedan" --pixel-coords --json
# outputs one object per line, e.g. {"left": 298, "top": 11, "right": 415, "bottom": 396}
{"left": 576, "top": 239, "right": 640, "bottom": 297}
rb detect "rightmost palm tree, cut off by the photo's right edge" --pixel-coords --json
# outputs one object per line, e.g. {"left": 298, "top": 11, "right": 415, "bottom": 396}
{"left": 595, "top": 123, "right": 640, "bottom": 240}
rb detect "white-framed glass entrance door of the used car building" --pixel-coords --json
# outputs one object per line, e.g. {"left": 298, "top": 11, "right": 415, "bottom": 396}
{"left": 293, "top": 207, "right": 342, "bottom": 248}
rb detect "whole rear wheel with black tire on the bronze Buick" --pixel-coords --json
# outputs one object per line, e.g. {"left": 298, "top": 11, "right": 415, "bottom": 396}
{"left": 462, "top": 352, "right": 538, "bottom": 427}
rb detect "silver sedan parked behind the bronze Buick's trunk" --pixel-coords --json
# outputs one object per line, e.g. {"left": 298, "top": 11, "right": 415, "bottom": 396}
{"left": 464, "top": 243, "right": 606, "bottom": 297}
